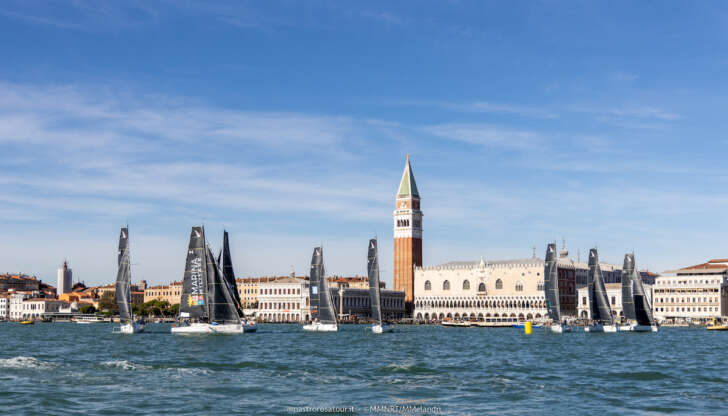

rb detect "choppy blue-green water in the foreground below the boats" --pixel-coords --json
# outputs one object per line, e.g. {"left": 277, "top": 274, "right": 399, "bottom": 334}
{"left": 0, "top": 323, "right": 728, "bottom": 415}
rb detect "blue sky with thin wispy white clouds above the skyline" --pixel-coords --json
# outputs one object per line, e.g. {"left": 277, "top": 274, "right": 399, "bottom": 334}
{"left": 0, "top": 0, "right": 728, "bottom": 286}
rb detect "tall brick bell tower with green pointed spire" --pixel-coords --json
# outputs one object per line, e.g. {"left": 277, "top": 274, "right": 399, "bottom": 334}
{"left": 393, "top": 155, "right": 422, "bottom": 314}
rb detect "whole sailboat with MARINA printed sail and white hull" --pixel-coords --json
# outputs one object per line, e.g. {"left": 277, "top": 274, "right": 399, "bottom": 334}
{"left": 172, "top": 227, "right": 243, "bottom": 334}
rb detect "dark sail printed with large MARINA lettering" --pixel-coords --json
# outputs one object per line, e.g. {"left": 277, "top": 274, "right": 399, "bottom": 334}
{"left": 179, "top": 227, "right": 209, "bottom": 320}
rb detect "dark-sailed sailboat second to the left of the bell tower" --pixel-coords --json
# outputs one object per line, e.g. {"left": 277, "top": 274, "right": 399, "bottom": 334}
{"left": 303, "top": 247, "right": 339, "bottom": 332}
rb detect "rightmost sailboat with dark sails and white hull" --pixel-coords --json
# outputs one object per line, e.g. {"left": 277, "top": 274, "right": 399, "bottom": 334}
{"left": 619, "top": 253, "right": 657, "bottom": 332}
